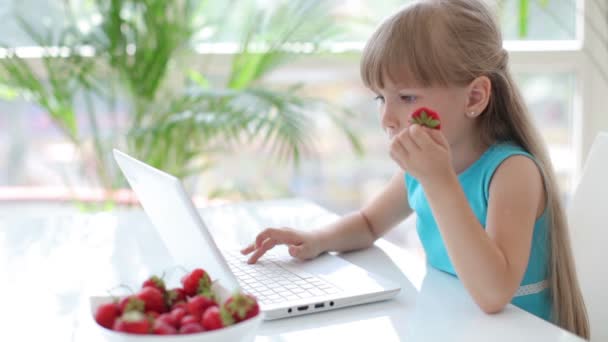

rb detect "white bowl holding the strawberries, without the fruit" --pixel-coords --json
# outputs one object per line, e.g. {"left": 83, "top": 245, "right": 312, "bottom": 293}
{"left": 90, "top": 286, "right": 264, "bottom": 342}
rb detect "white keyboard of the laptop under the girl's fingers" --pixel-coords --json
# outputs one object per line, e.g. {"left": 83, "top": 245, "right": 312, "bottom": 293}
{"left": 223, "top": 251, "right": 340, "bottom": 304}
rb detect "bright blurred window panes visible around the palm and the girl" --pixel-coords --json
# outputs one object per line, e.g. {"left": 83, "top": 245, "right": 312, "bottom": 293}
{"left": 0, "top": 0, "right": 608, "bottom": 212}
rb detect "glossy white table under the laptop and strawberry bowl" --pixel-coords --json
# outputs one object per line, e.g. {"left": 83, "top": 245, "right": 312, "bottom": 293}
{"left": 0, "top": 199, "right": 582, "bottom": 342}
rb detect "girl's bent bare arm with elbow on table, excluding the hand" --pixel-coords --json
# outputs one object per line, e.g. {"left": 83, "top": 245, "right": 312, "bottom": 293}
{"left": 423, "top": 156, "right": 545, "bottom": 313}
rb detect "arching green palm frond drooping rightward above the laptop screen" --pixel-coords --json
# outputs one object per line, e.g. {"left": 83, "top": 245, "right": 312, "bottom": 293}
{"left": 132, "top": 85, "right": 313, "bottom": 176}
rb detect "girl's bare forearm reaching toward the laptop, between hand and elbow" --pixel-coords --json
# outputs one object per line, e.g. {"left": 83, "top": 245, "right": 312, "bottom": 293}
{"left": 317, "top": 171, "right": 412, "bottom": 252}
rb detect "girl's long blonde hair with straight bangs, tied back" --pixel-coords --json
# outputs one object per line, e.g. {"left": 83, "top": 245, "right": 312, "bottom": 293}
{"left": 361, "top": 0, "right": 589, "bottom": 339}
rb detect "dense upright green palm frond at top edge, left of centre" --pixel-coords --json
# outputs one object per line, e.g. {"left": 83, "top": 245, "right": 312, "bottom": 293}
{"left": 88, "top": 0, "right": 200, "bottom": 101}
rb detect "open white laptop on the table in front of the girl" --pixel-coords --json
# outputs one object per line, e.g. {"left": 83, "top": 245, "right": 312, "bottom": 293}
{"left": 114, "top": 149, "right": 401, "bottom": 320}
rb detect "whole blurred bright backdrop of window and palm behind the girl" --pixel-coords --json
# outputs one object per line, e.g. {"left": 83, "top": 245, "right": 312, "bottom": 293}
{"left": 0, "top": 0, "right": 608, "bottom": 213}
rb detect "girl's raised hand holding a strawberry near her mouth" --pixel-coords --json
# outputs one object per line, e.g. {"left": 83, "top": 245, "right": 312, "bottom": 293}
{"left": 390, "top": 124, "right": 453, "bottom": 183}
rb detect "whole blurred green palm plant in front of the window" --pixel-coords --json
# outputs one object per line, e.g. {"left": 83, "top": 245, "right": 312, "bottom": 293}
{"left": 0, "top": 0, "right": 361, "bottom": 206}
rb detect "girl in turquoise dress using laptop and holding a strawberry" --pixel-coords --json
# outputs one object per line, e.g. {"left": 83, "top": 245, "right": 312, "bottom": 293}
{"left": 242, "top": 0, "right": 589, "bottom": 338}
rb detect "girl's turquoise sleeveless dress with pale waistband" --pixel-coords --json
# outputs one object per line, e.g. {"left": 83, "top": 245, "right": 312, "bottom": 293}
{"left": 405, "top": 143, "right": 552, "bottom": 321}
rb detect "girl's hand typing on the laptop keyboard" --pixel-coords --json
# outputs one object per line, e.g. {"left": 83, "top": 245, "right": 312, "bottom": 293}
{"left": 241, "top": 227, "right": 323, "bottom": 264}
